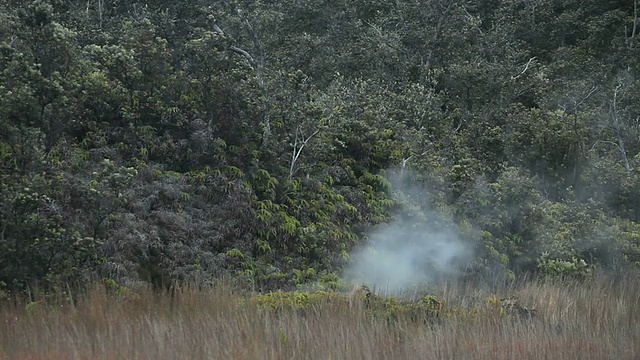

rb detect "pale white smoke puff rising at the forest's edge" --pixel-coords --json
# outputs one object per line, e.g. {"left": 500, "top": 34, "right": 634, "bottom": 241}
{"left": 343, "top": 169, "right": 473, "bottom": 294}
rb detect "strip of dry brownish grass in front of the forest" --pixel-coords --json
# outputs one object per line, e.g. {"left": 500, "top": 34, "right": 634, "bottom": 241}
{"left": 0, "top": 275, "right": 640, "bottom": 360}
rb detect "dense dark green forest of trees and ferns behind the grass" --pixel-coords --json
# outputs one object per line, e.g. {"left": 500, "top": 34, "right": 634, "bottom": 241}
{"left": 0, "top": 0, "right": 640, "bottom": 292}
